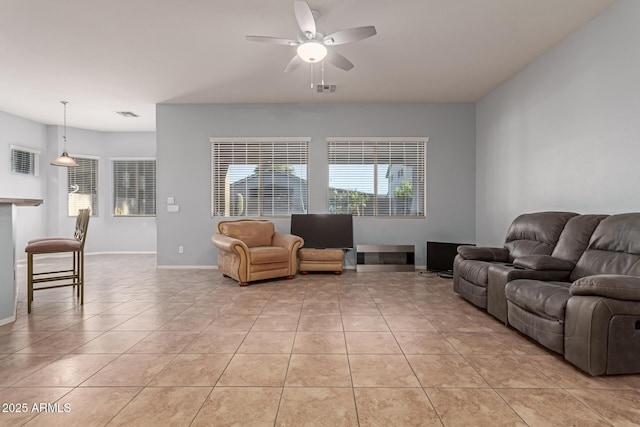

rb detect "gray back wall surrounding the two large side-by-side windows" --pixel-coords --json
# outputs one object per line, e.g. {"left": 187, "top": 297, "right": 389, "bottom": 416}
{"left": 156, "top": 104, "right": 475, "bottom": 266}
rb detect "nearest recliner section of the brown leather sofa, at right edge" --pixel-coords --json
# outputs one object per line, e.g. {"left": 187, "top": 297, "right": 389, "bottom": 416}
{"left": 505, "top": 213, "right": 640, "bottom": 375}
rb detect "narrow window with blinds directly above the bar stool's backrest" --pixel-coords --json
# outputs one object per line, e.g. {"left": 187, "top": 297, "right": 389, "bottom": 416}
{"left": 67, "top": 155, "right": 98, "bottom": 216}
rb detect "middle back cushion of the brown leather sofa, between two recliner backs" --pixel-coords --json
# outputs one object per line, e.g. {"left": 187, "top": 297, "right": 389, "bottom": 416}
{"left": 551, "top": 215, "right": 607, "bottom": 264}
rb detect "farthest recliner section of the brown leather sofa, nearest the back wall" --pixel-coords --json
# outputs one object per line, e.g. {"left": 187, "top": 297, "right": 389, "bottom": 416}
{"left": 453, "top": 212, "right": 578, "bottom": 310}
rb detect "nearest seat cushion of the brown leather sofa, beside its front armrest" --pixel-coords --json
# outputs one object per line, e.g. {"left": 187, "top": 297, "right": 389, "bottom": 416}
{"left": 505, "top": 279, "right": 571, "bottom": 322}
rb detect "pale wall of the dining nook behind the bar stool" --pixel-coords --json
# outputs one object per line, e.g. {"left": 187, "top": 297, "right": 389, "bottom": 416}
{"left": 0, "top": 112, "right": 157, "bottom": 259}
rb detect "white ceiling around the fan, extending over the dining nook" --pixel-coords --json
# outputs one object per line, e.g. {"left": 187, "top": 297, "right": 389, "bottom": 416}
{"left": 0, "top": 0, "right": 614, "bottom": 131}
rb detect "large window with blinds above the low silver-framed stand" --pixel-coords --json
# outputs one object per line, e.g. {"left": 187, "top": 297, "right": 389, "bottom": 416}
{"left": 327, "top": 138, "right": 428, "bottom": 217}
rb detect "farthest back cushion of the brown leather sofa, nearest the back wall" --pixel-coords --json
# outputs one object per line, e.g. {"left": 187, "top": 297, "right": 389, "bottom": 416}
{"left": 504, "top": 212, "right": 577, "bottom": 261}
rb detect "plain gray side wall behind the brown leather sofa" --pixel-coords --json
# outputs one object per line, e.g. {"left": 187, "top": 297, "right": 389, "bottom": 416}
{"left": 476, "top": 0, "right": 640, "bottom": 245}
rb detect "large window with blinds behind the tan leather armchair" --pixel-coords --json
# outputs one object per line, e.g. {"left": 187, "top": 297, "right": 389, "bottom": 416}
{"left": 211, "top": 138, "right": 310, "bottom": 217}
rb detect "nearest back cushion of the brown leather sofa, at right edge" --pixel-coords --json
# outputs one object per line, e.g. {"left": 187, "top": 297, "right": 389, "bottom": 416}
{"left": 570, "top": 213, "right": 640, "bottom": 281}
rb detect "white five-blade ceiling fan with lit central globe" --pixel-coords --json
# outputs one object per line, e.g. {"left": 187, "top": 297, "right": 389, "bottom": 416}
{"left": 246, "top": 0, "right": 376, "bottom": 73}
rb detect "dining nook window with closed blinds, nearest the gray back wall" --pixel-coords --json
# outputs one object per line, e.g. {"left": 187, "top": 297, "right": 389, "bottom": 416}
{"left": 112, "top": 159, "right": 156, "bottom": 216}
